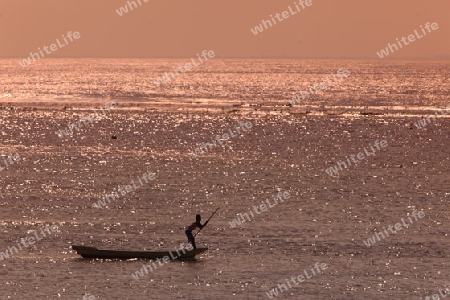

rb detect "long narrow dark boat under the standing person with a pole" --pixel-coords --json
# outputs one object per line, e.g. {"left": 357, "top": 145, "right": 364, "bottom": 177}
{"left": 72, "top": 245, "right": 208, "bottom": 260}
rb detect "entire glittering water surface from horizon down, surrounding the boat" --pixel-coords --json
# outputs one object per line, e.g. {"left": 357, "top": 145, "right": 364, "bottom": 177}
{"left": 0, "top": 59, "right": 450, "bottom": 300}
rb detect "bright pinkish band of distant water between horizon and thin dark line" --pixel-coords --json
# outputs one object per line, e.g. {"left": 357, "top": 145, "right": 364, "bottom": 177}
{"left": 0, "top": 59, "right": 450, "bottom": 107}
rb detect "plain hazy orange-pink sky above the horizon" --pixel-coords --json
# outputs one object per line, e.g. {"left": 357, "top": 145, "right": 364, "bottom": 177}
{"left": 0, "top": 0, "right": 450, "bottom": 59}
